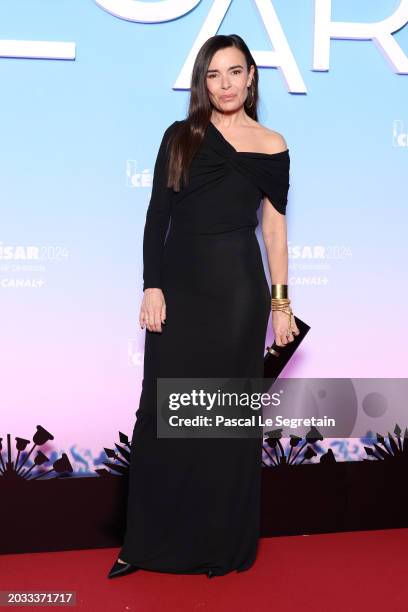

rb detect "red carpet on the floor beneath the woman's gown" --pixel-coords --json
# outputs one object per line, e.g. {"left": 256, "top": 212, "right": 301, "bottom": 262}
{"left": 0, "top": 529, "right": 408, "bottom": 612}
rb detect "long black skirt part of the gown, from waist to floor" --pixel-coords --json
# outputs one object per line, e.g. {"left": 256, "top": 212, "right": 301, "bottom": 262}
{"left": 119, "top": 227, "right": 271, "bottom": 575}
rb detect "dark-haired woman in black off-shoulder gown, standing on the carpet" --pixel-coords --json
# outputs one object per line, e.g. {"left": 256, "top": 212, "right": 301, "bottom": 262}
{"left": 109, "top": 35, "right": 299, "bottom": 578}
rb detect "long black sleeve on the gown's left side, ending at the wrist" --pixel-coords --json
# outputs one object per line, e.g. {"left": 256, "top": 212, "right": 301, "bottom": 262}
{"left": 143, "top": 121, "right": 178, "bottom": 291}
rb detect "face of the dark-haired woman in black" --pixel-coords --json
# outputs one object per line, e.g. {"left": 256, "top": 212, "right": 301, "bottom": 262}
{"left": 207, "top": 47, "right": 254, "bottom": 112}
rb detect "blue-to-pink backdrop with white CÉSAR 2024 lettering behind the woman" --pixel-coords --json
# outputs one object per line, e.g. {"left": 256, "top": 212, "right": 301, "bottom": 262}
{"left": 0, "top": 0, "right": 408, "bottom": 476}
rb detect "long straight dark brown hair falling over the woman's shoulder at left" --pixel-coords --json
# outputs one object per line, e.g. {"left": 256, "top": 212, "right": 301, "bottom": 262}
{"left": 167, "top": 34, "right": 258, "bottom": 191}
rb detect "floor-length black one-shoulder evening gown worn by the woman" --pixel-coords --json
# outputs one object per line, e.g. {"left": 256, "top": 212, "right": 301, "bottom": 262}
{"left": 119, "top": 121, "right": 290, "bottom": 575}
